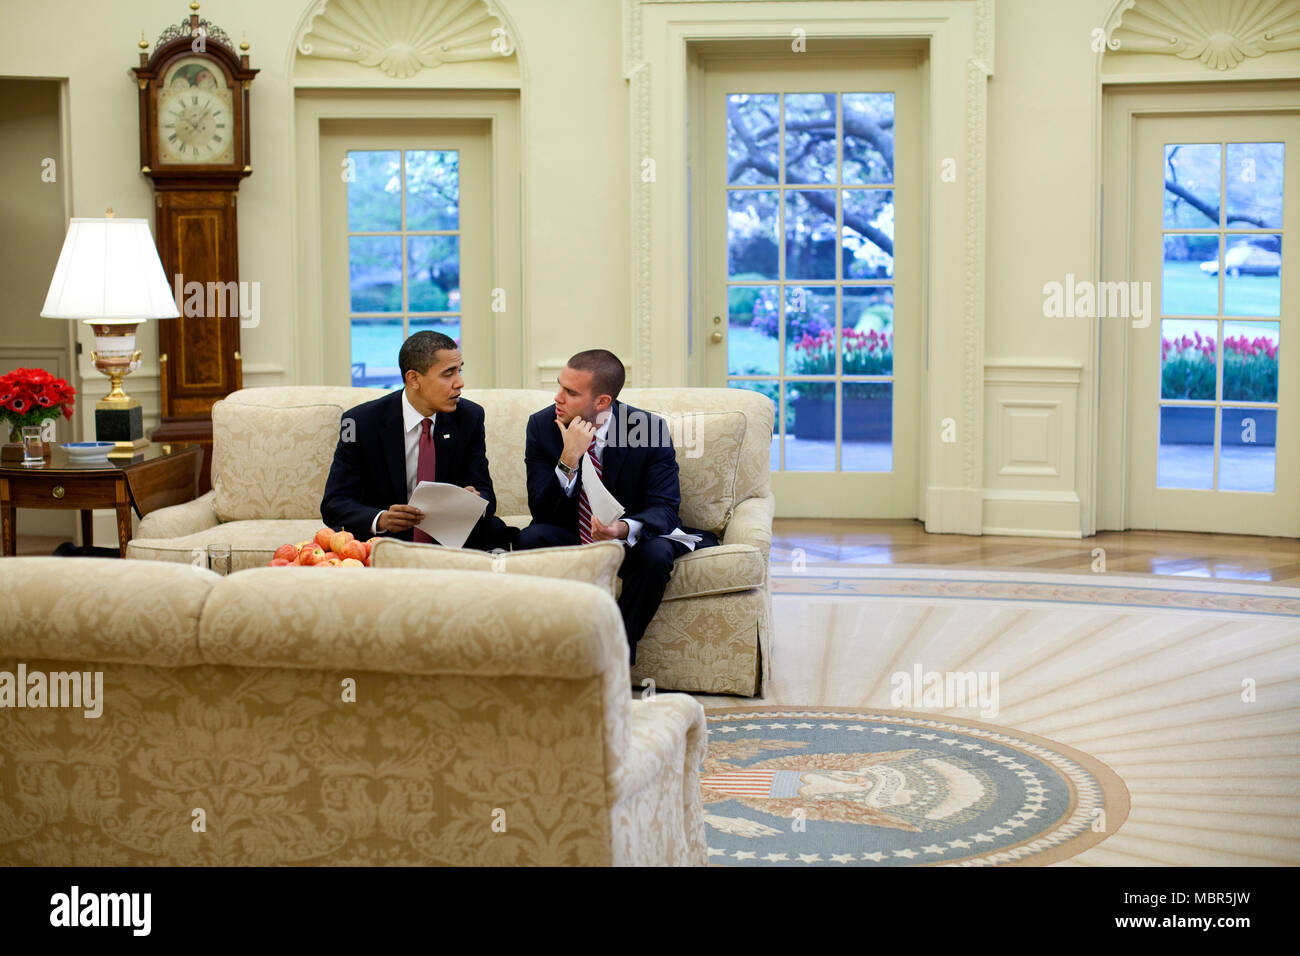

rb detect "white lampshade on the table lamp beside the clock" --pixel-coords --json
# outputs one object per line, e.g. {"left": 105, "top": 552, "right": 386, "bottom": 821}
{"left": 40, "top": 219, "right": 181, "bottom": 324}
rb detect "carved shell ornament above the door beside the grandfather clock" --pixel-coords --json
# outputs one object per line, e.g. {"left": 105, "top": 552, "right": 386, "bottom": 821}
{"left": 298, "top": 0, "right": 515, "bottom": 79}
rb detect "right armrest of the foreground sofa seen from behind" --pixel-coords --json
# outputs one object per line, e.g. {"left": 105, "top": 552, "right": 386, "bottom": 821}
{"left": 611, "top": 693, "right": 709, "bottom": 866}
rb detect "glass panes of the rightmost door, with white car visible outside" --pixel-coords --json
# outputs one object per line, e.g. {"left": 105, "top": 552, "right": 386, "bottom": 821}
{"left": 1156, "top": 142, "right": 1284, "bottom": 492}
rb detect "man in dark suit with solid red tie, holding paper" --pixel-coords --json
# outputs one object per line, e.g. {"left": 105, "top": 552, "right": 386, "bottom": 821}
{"left": 321, "top": 332, "right": 512, "bottom": 551}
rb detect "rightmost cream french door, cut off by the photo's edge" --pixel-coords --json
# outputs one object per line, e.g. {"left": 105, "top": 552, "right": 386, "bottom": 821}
{"left": 1127, "top": 113, "right": 1300, "bottom": 536}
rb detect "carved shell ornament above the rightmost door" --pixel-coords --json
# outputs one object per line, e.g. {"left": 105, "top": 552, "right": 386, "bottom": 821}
{"left": 1108, "top": 0, "right": 1300, "bottom": 70}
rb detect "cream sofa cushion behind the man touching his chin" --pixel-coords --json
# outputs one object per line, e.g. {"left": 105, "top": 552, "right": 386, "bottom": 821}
{"left": 644, "top": 411, "right": 745, "bottom": 535}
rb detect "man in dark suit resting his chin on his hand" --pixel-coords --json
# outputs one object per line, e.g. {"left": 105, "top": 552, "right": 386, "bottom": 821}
{"left": 515, "top": 349, "right": 718, "bottom": 663}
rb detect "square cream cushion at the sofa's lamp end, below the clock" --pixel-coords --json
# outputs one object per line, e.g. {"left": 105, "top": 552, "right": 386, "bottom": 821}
{"left": 212, "top": 402, "right": 343, "bottom": 522}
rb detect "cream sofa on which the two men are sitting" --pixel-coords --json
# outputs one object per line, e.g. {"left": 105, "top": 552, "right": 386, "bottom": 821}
{"left": 126, "top": 386, "right": 775, "bottom": 696}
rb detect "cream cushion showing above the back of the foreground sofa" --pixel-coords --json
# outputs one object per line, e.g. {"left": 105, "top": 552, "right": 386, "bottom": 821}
{"left": 371, "top": 538, "right": 623, "bottom": 597}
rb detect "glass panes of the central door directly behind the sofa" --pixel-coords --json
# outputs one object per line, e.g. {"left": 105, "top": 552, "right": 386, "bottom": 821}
{"left": 725, "top": 92, "right": 894, "bottom": 472}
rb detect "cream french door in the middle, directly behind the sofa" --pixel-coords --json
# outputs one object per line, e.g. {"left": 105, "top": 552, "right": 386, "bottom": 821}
{"left": 693, "top": 56, "right": 924, "bottom": 518}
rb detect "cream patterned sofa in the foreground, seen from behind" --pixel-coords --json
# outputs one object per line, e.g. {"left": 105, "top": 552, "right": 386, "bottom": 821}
{"left": 0, "top": 558, "right": 707, "bottom": 866}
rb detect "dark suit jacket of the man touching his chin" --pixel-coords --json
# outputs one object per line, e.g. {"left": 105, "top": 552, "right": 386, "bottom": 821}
{"left": 524, "top": 402, "right": 681, "bottom": 537}
